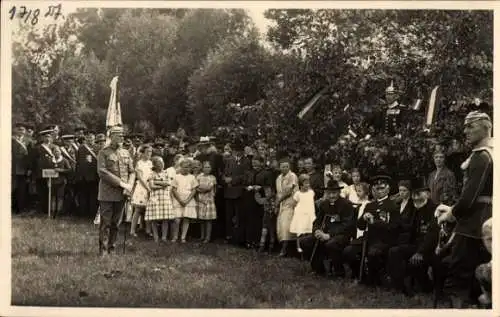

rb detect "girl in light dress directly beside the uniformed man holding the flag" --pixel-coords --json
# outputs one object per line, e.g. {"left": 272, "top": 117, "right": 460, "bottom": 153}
{"left": 130, "top": 145, "right": 153, "bottom": 237}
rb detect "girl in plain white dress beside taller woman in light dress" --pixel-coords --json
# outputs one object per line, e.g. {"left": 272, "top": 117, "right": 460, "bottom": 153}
{"left": 290, "top": 174, "right": 316, "bottom": 253}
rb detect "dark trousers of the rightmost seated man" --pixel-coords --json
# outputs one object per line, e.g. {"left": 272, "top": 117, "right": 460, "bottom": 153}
{"left": 387, "top": 244, "right": 432, "bottom": 291}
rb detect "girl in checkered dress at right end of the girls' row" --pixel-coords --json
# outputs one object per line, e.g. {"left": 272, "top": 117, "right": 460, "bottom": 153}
{"left": 196, "top": 161, "right": 217, "bottom": 243}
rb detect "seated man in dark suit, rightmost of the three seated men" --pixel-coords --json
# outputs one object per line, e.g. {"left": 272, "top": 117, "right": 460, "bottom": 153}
{"left": 387, "top": 178, "right": 439, "bottom": 296}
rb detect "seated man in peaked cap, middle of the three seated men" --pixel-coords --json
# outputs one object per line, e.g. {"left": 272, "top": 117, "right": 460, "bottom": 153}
{"left": 357, "top": 173, "right": 400, "bottom": 285}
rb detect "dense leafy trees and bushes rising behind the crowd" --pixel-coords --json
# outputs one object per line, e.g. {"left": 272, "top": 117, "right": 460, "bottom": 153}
{"left": 12, "top": 9, "right": 493, "bottom": 172}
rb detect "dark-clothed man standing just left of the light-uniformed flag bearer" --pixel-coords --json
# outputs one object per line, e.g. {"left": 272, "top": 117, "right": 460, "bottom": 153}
{"left": 75, "top": 130, "right": 99, "bottom": 217}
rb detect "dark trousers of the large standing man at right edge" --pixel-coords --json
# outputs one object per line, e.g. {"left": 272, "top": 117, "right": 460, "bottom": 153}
{"left": 443, "top": 234, "right": 491, "bottom": 302}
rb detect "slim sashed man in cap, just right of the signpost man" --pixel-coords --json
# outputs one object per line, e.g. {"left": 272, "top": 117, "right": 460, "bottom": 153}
{"left": 61, "top": 134, "right": 77, "bottom": 212}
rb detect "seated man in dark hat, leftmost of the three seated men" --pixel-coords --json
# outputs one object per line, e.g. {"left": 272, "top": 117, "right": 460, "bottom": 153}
{"left": 300, "top": 180, "right": 354, "bottom": 277}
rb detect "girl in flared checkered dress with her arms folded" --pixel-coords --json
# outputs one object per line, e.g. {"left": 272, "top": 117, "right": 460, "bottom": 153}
{"left": 145, "top": 156, "right": 178, "bottom": 242}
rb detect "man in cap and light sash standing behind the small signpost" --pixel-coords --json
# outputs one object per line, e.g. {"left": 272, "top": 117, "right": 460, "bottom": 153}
{"left": 33, "top": 130, "right": 55, "bottom": 213}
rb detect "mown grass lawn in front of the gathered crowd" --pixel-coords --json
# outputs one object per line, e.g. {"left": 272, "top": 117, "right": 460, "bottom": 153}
{"left": 12, "top": 217, "right": 432, "bottom": 308}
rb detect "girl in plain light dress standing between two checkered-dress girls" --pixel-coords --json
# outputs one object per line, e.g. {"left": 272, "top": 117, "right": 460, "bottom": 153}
{"left": 172, "top": 159, "right": 198, "bottom": 243}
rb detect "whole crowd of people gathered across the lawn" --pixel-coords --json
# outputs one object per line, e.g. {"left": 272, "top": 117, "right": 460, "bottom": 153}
{"left": 12, "top": 105, "right": 493, "bottom": 307}
